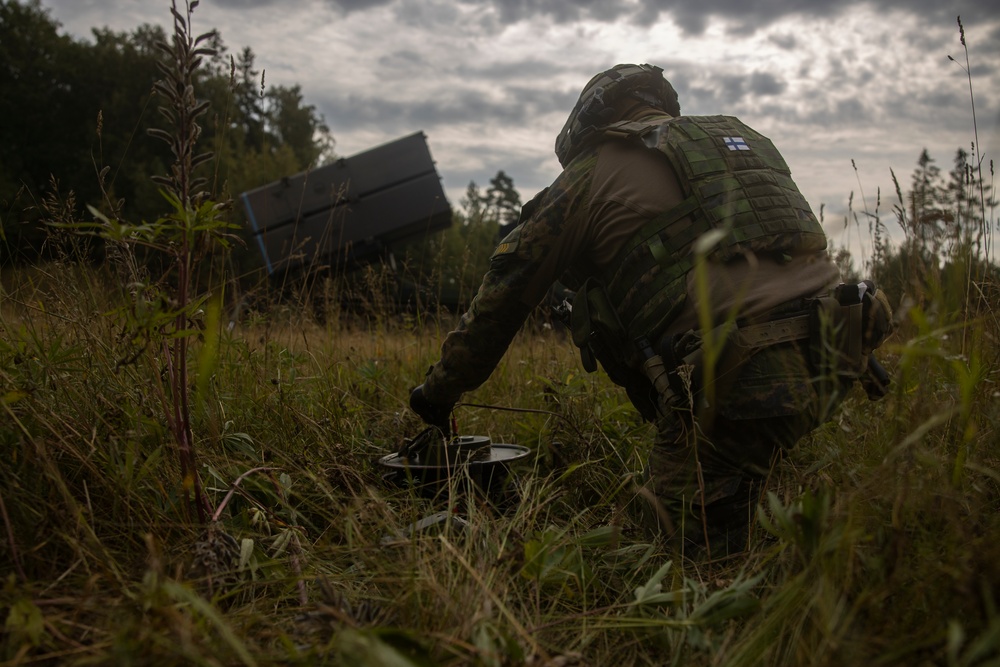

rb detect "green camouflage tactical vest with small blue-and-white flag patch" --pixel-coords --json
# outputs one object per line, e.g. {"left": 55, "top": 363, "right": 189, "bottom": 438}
{"left": 597, "top": 116, "right": 826, "bottom": 342}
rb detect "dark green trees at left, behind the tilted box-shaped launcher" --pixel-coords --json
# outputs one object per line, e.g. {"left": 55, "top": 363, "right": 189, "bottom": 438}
{"left": 0, "top": 0, "right": 334, "bottom": 265}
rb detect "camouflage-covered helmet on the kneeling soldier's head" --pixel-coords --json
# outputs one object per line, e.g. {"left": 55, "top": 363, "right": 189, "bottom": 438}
{"left": 556, "top": 65, "right": 681, "bottom": 167}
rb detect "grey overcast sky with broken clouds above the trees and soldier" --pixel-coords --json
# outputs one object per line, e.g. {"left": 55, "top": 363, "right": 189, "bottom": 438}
{"left": 42, "top": 0, "right": 1000, "bottom": 260}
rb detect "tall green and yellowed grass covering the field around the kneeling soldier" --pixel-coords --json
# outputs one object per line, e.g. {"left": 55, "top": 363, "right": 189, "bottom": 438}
{"left": 0, "top": 3, "right": 1000, "bottom": 667}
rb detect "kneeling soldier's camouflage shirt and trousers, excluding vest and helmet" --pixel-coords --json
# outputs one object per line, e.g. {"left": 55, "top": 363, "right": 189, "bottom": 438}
{"left": 423, "top": 108, "right": 839, "bottom": 552}
